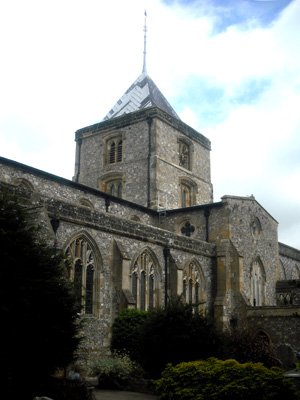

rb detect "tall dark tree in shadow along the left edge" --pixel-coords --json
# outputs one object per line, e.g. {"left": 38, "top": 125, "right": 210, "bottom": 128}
{"left": 0, "top": 192, "right": 78, "bottom": 398}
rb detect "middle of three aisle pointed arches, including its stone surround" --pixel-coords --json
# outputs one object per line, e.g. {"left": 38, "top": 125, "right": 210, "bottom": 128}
{"left": 130, "top": 247, "right": 161, "bottom": 311}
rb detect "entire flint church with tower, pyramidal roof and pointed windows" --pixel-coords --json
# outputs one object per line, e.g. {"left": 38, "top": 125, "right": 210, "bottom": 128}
{"left": 0, "top": 18, "right": 300, "bottom": 368}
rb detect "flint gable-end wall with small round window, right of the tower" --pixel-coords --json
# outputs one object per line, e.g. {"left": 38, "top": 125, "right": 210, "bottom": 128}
{"left": 211, "top": 196, "right": 280, "bottom": 305}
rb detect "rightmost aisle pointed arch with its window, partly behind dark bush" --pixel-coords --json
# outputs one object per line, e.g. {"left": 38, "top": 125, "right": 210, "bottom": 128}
{"left": 182, "top": 258, "right": 205, "bottom": 310}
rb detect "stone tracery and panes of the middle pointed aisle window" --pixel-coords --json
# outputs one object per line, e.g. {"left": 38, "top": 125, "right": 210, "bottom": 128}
{"left": 131, "top": 251, "right": 158, "bottom": 311}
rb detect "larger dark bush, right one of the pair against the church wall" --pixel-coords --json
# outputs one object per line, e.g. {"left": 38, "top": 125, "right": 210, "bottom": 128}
{"left": 141, "top": 297, "right": 223, "bottom": 378}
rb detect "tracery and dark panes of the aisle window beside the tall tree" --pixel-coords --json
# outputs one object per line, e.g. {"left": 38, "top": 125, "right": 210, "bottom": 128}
{"left": 66, "top": 237, "right": 95, "bottom": 314}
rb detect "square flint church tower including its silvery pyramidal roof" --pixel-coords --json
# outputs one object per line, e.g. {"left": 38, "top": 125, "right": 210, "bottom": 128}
{"left": 73, "top": 72, "right": 213, "bottom": 210}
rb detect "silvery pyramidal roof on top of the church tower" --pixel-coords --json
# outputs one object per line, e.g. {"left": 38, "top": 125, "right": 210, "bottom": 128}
{"left": 103, "top": 72, "right": 180, "bottom": 121}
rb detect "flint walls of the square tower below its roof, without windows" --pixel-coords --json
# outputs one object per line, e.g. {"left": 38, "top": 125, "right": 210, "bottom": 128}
{"left": 75, "top": 107, "right": 212, "bottom": 208}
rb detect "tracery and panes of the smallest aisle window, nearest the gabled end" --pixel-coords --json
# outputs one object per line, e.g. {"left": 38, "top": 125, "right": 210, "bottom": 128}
{"left": 183, "top": 262, "right": 203, "bottom": 309}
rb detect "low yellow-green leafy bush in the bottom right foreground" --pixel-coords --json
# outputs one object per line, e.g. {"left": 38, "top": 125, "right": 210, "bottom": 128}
{"left": 157, "top": 358, "right": 298, "bottom": 400}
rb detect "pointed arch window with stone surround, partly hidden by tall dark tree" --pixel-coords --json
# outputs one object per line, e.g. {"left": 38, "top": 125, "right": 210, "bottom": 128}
{"left": 63, "top": 231, "right": 102, "bottom": 316}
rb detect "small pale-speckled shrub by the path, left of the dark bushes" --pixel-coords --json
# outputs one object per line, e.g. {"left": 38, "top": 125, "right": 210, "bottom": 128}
{"left": 90, "top": 352, "right": 142, "bottom": 389}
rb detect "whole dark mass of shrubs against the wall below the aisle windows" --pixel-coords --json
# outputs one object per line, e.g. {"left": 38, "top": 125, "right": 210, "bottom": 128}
{"left": 112, "top": 296, "right": 224, "bottom": 379}
